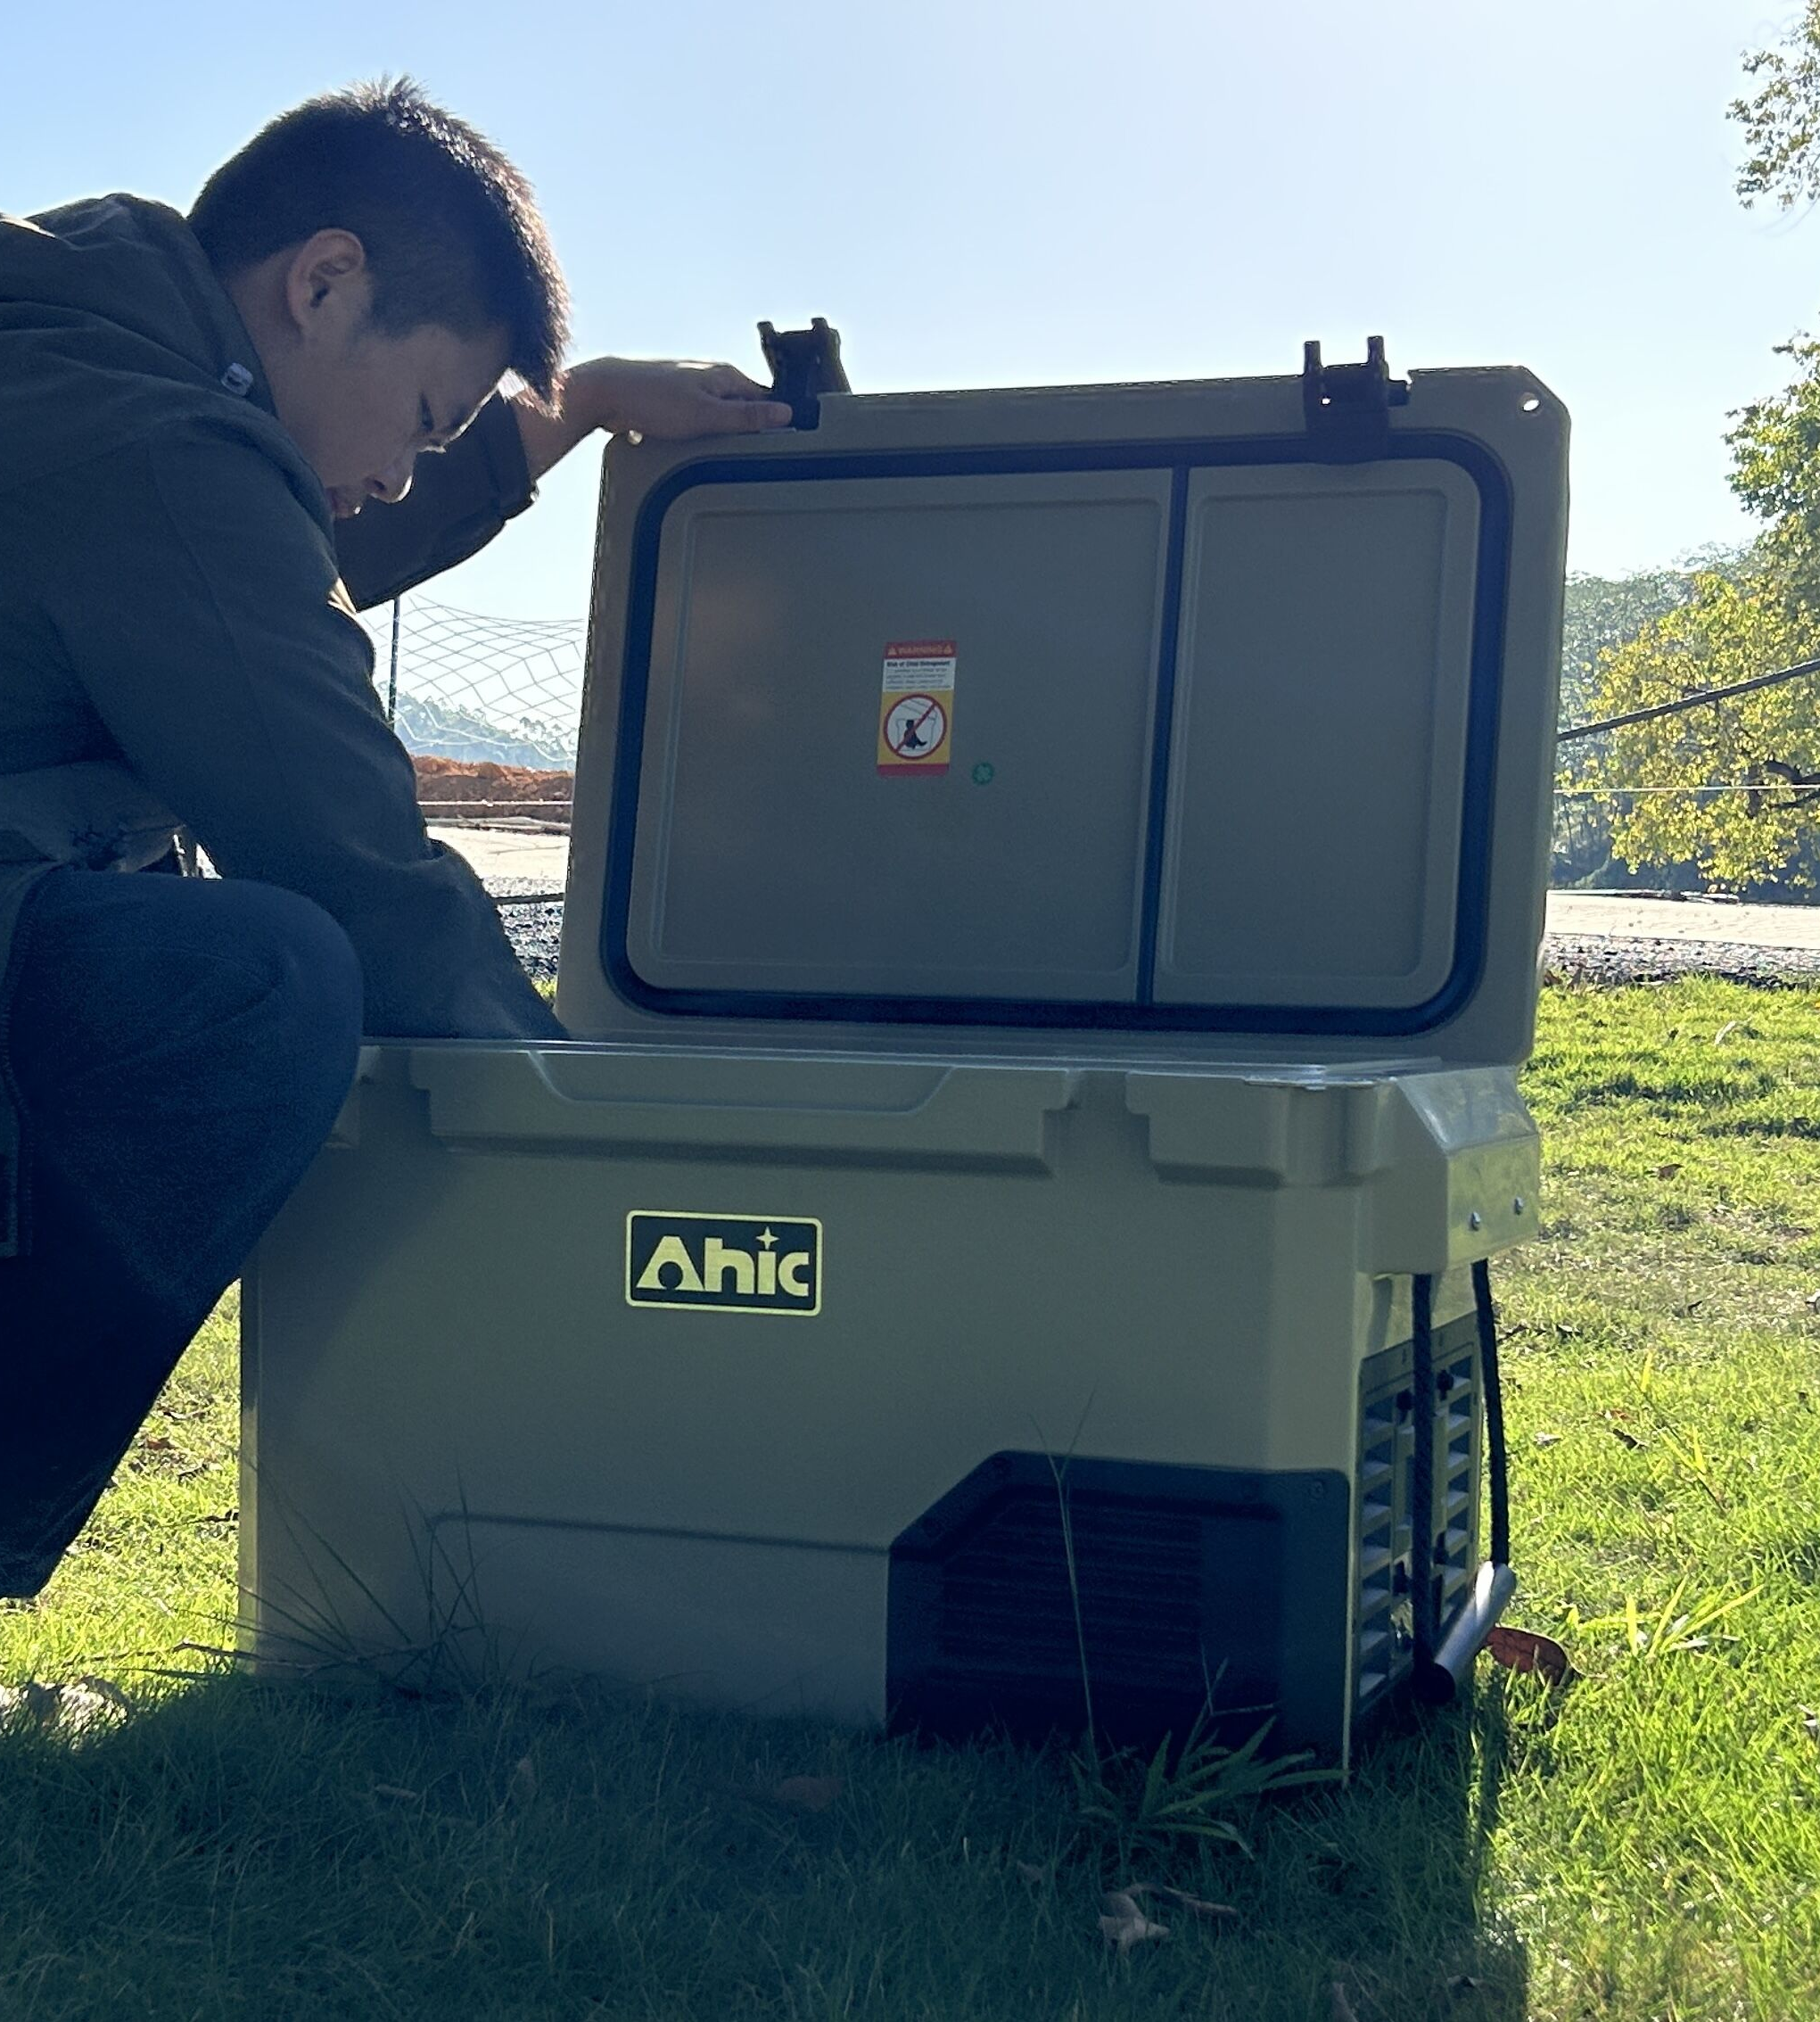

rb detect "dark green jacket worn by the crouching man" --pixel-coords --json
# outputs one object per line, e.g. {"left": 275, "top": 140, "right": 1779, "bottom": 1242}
{"left": 0, "top": 196, "right": 560, "bottom": 1254}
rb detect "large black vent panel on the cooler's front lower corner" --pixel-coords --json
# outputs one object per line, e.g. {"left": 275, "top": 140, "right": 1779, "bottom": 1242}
{"left": 890, "top": 1454, "right": 1346, "bottom": 1749}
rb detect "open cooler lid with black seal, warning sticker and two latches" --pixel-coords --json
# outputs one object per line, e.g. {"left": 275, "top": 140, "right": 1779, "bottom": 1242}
{"left": 558, "top": 332, "right": 1568, "bottom": 1066}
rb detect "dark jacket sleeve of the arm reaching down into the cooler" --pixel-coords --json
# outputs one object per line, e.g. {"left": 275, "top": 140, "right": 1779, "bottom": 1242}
{"left": 30, "top": 437, "right": 562, "bottom": 1037}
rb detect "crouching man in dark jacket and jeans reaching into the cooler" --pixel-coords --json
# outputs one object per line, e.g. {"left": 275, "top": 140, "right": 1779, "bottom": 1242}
{"left": 0, "top": 83, "right": 788, "bottom": 1596}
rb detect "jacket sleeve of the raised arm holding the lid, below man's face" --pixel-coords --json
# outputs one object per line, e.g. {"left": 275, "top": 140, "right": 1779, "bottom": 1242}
{"left": 335, "top": 394, "right": 536, "bottom": 611}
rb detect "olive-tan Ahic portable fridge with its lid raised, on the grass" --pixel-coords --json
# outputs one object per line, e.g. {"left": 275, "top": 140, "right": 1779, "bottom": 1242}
{"left": 241, "top": 343, "right": 1568, "bottom": 1763}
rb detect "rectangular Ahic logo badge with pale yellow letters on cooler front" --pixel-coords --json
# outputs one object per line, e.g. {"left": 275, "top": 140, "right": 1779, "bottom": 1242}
{"left": 625, "top": 1209, "right": 821, "bottom": 1315}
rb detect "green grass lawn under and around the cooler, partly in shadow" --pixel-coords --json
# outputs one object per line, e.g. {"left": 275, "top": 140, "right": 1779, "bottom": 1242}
{"left": 0, "top": 983, "right": 1820, "bottom": 2022}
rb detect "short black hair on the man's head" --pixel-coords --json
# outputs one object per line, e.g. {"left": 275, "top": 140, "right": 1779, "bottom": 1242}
{"left": 190, "top": 77, "right": 568, "bottom": 407}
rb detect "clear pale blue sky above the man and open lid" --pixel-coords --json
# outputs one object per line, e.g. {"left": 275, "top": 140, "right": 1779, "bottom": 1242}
{"left": 0, "top": 0, "right": 1820, "bottom": 616}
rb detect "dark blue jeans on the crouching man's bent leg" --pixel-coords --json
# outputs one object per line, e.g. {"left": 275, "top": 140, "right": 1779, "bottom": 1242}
{"left": 0, "top": 870, "right": 360, "bottom": 1596}
